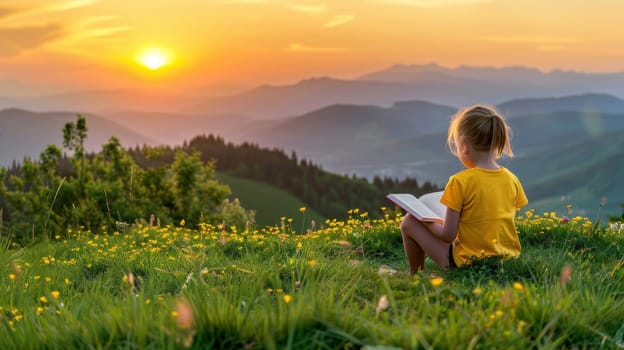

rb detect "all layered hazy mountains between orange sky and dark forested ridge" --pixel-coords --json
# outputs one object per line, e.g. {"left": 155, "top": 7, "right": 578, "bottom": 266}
{"left": 0, "top": 65, "right": 624, "bottom": 216}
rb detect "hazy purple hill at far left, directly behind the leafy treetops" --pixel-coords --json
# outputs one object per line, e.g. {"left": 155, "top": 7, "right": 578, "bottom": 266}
{"left": 0, "top": 108, "right": 159, "bottom": 166}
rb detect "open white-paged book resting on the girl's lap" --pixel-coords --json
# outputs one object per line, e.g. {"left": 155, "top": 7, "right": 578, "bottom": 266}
{"left": 386, "top": 191, "right": 446, "bottom": 223}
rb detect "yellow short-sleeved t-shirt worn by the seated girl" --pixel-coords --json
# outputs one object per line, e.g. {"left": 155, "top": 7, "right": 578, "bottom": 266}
{"left": 440, "top": 167, "right": 528, "bottom": 266}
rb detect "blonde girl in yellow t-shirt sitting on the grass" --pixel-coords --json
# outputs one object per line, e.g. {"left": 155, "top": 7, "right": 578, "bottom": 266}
{"left": 401, "top": 105, "right": 528, "bottom": 274}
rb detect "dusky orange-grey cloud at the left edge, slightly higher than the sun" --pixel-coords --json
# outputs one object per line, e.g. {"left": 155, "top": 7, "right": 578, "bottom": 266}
{"left": 0, "top": 24, "right": 66, "bottom": 56}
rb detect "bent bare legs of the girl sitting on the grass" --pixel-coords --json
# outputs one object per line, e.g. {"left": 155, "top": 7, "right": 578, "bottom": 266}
{"left": 401, "top": 214, "right": 450, "bottom": 274}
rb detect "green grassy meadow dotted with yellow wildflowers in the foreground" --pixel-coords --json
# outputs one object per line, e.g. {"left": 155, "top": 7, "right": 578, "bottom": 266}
{"left": 0, "top": 210, "right": 624, "bottom": 349}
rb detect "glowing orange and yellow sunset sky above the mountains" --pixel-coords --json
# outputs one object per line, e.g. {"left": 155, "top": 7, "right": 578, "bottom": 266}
{"left": 0, "top": 0, "right": 624, "bottom": 94}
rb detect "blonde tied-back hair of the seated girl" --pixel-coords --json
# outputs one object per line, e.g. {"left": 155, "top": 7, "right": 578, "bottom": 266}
{"left": 447, "top": 104, "right": 513, "bottom": 157}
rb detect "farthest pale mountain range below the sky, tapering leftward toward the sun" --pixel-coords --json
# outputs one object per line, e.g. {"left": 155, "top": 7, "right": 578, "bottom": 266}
{"left": 187, "top": 64, "right": 624, "bottom": 119}
